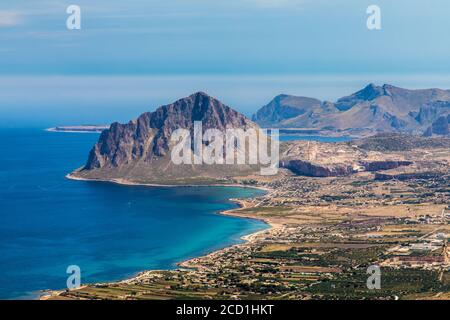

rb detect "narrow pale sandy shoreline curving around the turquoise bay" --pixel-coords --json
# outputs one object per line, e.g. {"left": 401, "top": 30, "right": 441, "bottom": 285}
{"left": 41, "top": 172, "right": 274, "bottom": 300}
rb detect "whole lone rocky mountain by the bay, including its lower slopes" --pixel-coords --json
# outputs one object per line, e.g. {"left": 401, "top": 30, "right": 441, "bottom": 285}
{"left": 71, "top": 92, "right": 258, "bottom": 184}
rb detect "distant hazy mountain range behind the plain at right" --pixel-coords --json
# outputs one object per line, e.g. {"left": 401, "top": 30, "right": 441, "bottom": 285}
{"left": 252, "top": 84, "right": 450, "bottom": 136}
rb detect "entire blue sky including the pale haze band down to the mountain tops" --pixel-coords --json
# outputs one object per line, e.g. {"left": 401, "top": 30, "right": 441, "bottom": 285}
{"left": 0, "top": 0, "right": 450, "bottom": 125}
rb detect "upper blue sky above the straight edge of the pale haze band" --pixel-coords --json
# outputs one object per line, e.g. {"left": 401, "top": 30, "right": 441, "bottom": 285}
{"left": 0, "top": 0, "right": 450, "bottom": 74}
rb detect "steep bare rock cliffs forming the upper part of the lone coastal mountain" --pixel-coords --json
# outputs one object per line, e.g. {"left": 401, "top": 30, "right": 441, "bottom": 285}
{"left": 84, "top": 92, "right": 255, "bottom": 170}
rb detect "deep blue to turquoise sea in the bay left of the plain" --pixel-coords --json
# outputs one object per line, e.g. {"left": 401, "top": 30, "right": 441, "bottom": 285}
{"left": 0, "top": 129, "right": 267, "bottom": 299}
